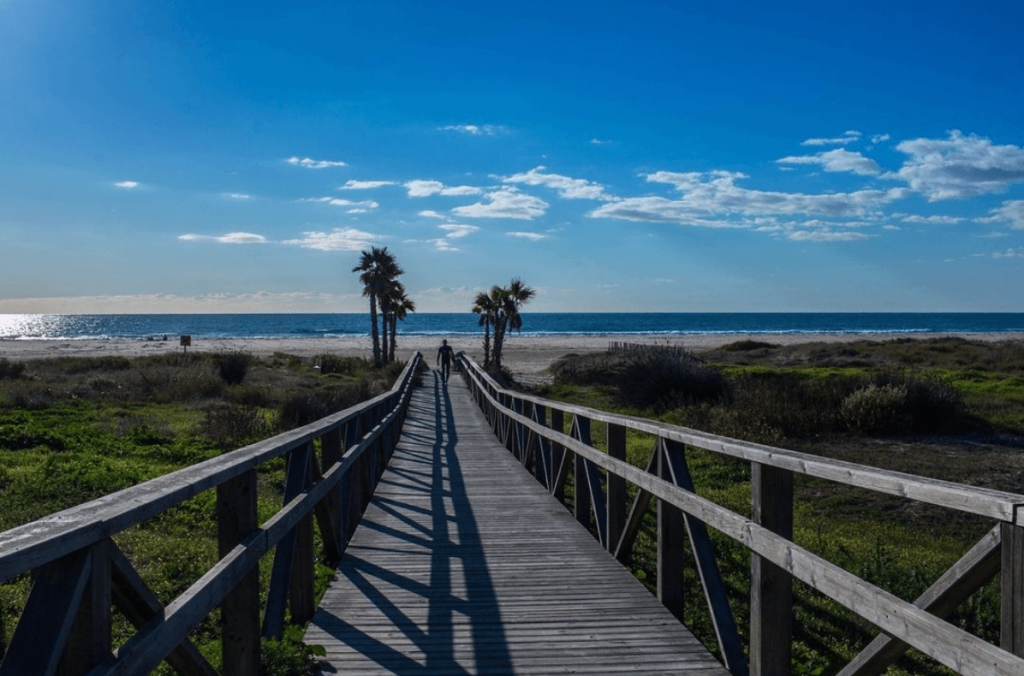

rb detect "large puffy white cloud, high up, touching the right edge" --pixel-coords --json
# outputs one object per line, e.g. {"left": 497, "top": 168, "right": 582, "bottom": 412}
{"left": 894, "top": 130, "right": 1024, "bottom": 197}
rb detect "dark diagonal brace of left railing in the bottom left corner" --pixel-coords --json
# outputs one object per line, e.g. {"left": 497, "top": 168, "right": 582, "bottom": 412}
{"left": 0, "top": 548, "right": 92, "bottom": 676}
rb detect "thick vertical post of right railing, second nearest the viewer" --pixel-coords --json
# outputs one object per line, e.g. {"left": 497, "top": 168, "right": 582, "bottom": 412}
{"left": 750, "top": 463, "right": 793, "bottom": 676}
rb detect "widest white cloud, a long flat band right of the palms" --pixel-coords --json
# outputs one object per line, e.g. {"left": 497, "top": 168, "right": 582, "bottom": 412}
{"left": 587, "top": 171, "right": 909, "bottom": 227}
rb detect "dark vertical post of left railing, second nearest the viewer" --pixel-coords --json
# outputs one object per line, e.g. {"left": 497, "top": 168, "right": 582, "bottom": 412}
{"left": 217, "top": 469, "right": 260, "bottom": 676}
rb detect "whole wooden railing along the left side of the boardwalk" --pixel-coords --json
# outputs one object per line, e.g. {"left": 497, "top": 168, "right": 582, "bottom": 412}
{"left": 0, "top": 354, "right": 422, "bottom": 676}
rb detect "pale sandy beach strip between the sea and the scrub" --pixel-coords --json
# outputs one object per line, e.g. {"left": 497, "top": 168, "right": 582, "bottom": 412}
{"left": 0, "top": 333, "right": 1024, "bottom": 382}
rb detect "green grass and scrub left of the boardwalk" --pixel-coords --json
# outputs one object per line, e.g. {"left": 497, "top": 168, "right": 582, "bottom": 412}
{"left": 0, "top": 354, "right": 402, "bottom": 675}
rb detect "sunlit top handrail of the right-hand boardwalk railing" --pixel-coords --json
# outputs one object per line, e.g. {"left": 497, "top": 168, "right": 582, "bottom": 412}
{"left": 464, "top": 357, "right": 1024, "bottom": 525}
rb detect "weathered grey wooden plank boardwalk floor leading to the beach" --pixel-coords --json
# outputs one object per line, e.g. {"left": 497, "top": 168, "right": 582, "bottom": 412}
{"left": 305, "top": 371, "right": 728, "bottom": 676}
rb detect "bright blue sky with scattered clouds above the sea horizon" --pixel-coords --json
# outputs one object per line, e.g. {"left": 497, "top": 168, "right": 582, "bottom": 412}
{"left": 0, "top": 0, "right": 1024, "bottom": 312}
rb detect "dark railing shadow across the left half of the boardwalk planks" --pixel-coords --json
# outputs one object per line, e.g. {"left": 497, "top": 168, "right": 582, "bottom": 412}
{"left": 318, "top": 372, "right": 514, "bottom": 676}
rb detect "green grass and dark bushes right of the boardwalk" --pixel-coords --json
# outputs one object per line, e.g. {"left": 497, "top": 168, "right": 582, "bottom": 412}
{"left": 537, "top": 339, "right": 1024, "bottom": 675}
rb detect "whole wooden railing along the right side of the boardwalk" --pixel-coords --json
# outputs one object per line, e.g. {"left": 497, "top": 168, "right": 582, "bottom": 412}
{"left": 461, "top": 357, "right": 1024, "bottom": 676}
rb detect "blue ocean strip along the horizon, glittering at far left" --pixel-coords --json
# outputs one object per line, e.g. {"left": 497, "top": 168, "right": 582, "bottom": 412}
{"left": 0, "top": 312, "right": 1024, "bottom": 340}
